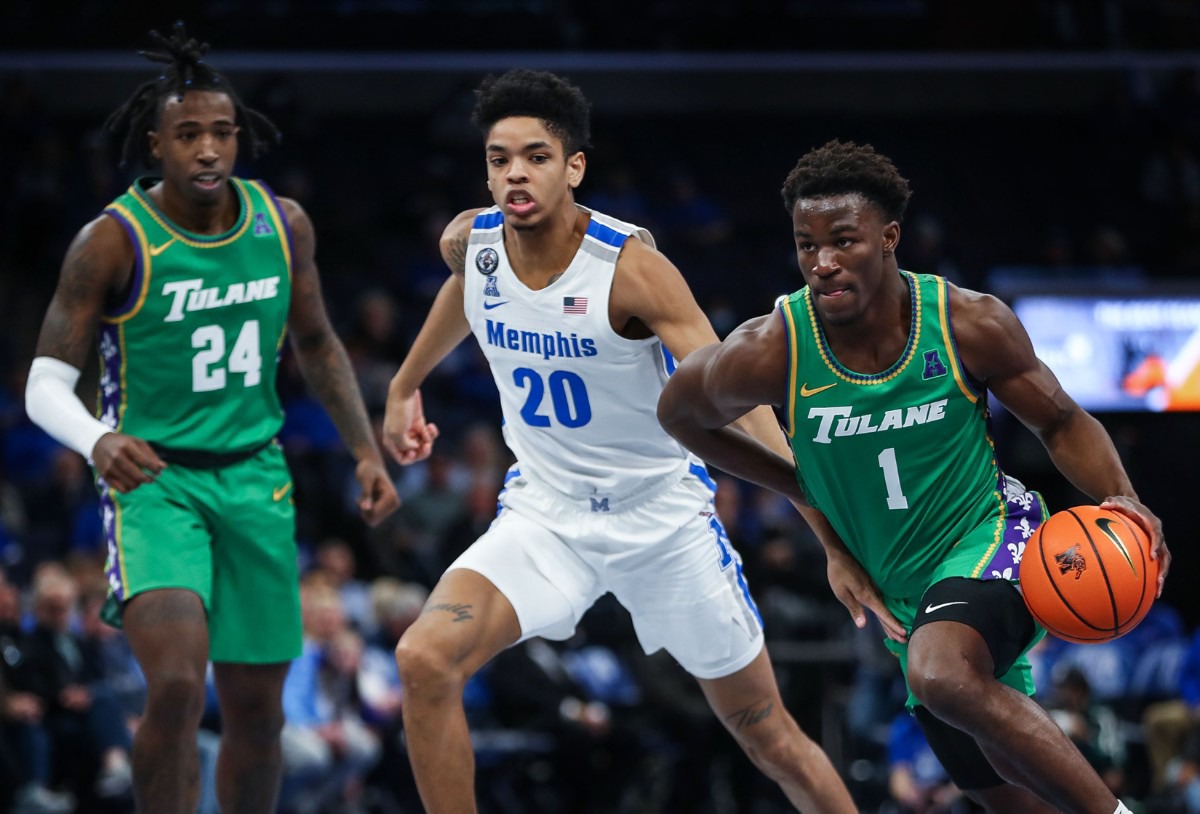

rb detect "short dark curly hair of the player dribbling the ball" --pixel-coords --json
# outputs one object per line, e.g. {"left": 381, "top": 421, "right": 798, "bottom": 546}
{"left": 782, "top": 139, "right": 912, "bottom": 223}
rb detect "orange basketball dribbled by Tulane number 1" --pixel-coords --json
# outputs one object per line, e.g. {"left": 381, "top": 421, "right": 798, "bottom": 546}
{"left": 1020, "top": 505, "right": 1159, "bottom": 644}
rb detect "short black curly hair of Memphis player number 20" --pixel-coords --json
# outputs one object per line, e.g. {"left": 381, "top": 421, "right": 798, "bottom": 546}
{"left": 470, "top": 68, "right": 592, "bottom": 155}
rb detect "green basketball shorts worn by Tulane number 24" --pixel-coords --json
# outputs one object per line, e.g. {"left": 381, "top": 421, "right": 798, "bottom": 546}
{"left": 97, "top": 443, "right": 301, "bottom": 664}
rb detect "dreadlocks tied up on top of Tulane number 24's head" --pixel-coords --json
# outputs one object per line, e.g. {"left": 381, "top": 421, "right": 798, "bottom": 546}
{"left": 104, "top": 20, "right": 281, "bottom": 167}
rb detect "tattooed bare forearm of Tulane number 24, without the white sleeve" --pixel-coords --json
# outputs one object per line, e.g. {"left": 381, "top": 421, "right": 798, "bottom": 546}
{"left": 295, "top": 334, "right": 382, "bottom": 461}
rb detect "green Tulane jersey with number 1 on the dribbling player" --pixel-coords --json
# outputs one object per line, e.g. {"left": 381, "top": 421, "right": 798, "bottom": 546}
{"left": 780, "top": 271, "right": 1006, "bottom": 598}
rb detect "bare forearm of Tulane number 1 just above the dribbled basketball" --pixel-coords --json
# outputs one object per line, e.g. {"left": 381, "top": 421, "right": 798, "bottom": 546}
{"left": 1042, "top": 409, "right": 1138, "bottom": 502}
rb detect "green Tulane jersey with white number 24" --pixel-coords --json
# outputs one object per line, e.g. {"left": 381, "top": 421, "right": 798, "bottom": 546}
{"left": 98, "top": 178, "right": 292, "bottom": 454}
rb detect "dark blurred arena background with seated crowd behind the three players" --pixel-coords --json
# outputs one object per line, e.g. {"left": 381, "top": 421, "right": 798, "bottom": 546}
{"left": 0, "top": 0, "right": 1200, "bottom": 814}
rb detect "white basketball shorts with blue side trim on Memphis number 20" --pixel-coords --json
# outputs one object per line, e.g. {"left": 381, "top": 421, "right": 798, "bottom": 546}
{"left": 448, "top": 465, "right": 763, "bottom": 678}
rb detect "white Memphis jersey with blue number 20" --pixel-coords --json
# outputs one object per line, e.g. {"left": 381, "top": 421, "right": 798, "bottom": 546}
{"left": 463, "top": 207, "right": 695, "bottom": 501}
